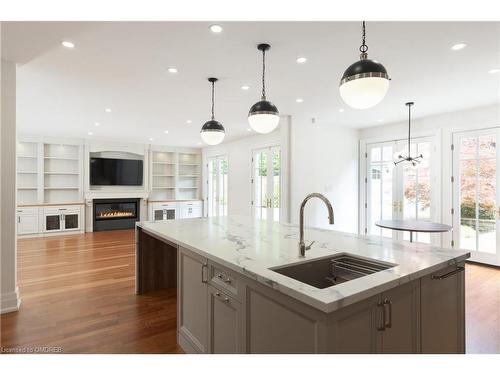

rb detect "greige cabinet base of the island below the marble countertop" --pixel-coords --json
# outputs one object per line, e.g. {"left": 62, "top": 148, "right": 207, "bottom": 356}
{"left": 178, "top": 248, "right": 465, "bottom": 354}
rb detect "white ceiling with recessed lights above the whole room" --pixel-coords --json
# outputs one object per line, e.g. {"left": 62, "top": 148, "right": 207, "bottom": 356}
{"left": 2, "top": 22, "right": 500, "bottom": 147}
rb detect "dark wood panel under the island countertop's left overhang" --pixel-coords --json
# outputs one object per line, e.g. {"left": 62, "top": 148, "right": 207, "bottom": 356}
{"left": 136, "top": 228, "right": 177, "bottom": 294}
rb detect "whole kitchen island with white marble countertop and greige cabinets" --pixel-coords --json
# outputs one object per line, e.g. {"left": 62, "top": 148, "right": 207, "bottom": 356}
{"left": 136, "top": 217, "right": 470, "bottom": 353}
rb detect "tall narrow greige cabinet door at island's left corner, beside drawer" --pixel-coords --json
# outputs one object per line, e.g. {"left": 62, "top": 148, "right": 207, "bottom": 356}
{"left": 178, "top": 248, "right": 208, "bottom": 353}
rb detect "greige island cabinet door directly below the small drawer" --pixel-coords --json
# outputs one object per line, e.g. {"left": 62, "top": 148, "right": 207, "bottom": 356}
{"left": 208, "top": 287, "right": 243, "bottom": 354}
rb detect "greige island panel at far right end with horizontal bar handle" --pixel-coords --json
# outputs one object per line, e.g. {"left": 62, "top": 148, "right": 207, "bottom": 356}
{"left": 421, "top": 266, "right": 465, "bottom": 353}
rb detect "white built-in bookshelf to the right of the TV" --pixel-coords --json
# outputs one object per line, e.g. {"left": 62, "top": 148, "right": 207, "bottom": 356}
{"left": 150, "top": 150, "right": 201, "bottom": 200}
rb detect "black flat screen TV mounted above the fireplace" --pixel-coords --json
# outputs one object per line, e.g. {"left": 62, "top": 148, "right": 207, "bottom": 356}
{"left": 90, "top": 157, "right": 142, "bottom": 186}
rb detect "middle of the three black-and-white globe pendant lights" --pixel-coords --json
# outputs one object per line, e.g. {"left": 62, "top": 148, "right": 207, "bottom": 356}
{"left": 248, "top": 43, "right": 280, "bottom": 134}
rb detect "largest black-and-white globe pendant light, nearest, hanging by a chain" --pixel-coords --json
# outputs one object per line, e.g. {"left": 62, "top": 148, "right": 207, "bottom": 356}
{"left": 339, "top": 21, "right": 390, "bottom": 109}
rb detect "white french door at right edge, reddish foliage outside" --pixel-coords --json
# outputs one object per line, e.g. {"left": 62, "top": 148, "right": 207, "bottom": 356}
{"left": 452, "top": 129, "right": 500, "bottom": 265}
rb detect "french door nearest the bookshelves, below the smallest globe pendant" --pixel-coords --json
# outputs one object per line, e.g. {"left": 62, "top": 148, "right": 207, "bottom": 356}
{"left": 207, "top": 155, "right": 229, "bottom": 216}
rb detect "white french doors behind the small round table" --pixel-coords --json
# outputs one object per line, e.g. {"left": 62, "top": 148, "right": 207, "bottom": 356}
{"left": 365, "top": 137, "right": 437, "bottom": 243}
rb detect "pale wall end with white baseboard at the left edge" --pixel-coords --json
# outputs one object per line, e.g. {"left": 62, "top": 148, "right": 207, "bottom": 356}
{"left": 0, "top": 60, "right": 21, "bottom": 314}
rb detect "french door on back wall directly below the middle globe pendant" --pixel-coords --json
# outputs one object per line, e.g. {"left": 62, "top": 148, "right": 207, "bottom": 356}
{"left": 252, "top": 146, "right": 281, "bottom": 221}
